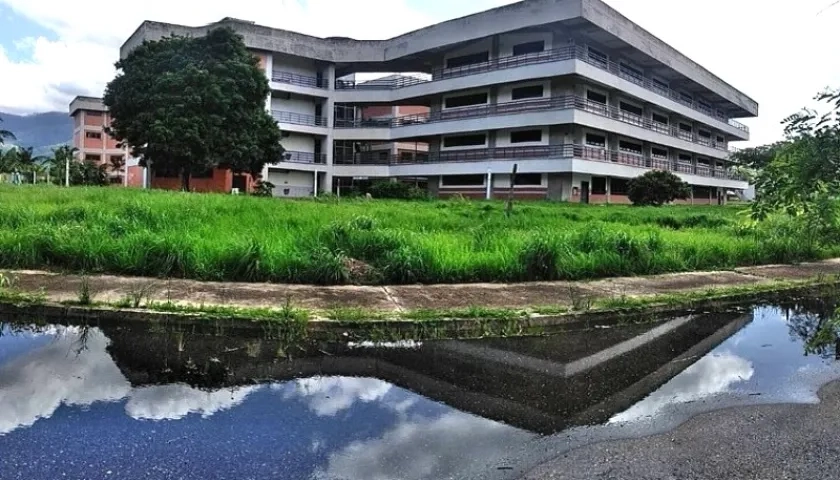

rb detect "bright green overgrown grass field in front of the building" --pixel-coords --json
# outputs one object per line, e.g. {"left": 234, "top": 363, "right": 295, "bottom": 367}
{"left": 0, "top": 186, "right": 840, "bottom": 284}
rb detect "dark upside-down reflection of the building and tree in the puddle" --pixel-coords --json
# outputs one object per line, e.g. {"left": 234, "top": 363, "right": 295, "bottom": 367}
{"left": 97, "top": 313, "right": 752, "bottom": 433}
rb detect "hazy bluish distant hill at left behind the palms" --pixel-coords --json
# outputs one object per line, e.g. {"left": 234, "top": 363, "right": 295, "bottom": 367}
{"left": 0, "top": 112, "right": 73, "bottom": 155}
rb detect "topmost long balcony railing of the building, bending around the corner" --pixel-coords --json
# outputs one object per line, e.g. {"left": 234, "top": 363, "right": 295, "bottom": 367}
{"left": 335, "top": 45, "right": 750, "bottom": 133}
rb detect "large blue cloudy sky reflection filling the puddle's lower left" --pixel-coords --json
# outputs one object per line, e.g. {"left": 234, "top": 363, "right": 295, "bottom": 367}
{"left": 0, "top": 328, "right": 533, "bottom": 480}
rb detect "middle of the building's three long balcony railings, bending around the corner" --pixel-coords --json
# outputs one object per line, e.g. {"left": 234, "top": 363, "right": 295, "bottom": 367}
{"left": 335, "top": 95, "right": 728, "bottom": 151}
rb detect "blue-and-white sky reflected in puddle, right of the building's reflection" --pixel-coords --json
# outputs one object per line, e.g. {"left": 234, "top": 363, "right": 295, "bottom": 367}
{"left": 611, "top": 308, "right": 840, "bottom": 422}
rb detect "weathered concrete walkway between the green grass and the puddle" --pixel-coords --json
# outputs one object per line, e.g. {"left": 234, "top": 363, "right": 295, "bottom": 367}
{"left": 2, "top": 259, "right": 840, "bottom": 313}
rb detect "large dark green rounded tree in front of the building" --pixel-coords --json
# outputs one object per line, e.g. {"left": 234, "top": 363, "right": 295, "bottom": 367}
{"left": 104, "top": 28, "right": 283, "bottom": 190}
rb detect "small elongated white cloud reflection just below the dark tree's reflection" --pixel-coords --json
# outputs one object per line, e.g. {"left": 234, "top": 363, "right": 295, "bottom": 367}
{"left": 125, "top": 383, "right": 259, "bottom": 420}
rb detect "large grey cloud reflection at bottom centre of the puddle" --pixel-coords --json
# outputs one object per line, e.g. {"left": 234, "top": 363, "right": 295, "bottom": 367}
{"left": 313, "top": 412, "right": 535, "bottom": 480}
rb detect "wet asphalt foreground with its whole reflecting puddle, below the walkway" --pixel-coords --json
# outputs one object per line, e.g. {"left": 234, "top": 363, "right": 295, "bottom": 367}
{"left": 0, "top": 298, "right": 840, "bottom": 480}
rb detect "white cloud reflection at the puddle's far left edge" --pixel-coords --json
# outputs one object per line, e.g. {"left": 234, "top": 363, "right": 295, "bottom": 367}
{"left": 0, "top": 328, "right": 131, "bottom": 435}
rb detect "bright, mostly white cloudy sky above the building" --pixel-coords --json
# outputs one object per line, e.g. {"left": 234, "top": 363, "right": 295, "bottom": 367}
{"left": 0, "top": 0, "right": 840, "bottom": 143}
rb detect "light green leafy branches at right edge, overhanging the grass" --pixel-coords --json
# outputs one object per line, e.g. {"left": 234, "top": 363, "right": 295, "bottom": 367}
{"left": 752, "top": 86, "right": 840, "bottom": 245}
